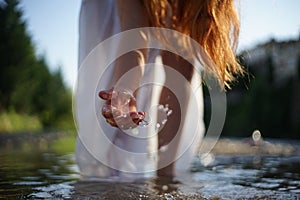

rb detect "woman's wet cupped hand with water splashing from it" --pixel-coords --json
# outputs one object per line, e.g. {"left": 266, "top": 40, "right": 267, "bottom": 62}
{"left": 99, "top": 89, "right": 145, "bottom": 130}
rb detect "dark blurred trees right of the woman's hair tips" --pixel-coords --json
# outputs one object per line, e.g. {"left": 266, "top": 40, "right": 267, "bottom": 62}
{"left": 223, "top": 52, "right": 300, "bottom": 139}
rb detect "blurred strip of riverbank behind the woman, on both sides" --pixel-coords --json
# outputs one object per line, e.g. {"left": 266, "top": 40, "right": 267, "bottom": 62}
{"left": 0, "top": 132, "right": 300, "bottom": 156}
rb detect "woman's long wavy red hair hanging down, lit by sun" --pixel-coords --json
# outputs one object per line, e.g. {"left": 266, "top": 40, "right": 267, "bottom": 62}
{"left": 142, "top": 0, "right": 243, "bottom": 88}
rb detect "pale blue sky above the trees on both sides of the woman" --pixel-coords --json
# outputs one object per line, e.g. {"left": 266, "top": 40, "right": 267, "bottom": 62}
{"left": 20, "top": 0, "right": 300, "bottom": 87}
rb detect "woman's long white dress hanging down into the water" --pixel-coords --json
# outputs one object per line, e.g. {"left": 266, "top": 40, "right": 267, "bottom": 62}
{"left": 75, "top": 0, "right": 204, "bottom": 180}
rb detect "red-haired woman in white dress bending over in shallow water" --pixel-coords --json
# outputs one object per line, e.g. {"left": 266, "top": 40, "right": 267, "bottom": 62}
{"left": 76, "top": 0, "right": 243, "bottom": 179}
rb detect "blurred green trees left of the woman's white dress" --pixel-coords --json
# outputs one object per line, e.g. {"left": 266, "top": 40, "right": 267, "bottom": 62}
{"left": 0, "top": 0, "right": 74, "bottom": 131}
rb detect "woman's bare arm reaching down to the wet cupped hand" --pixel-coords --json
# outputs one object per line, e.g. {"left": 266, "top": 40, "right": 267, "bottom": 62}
{"left": 112, "top": 0, "right": 148, "bottom": 91}
